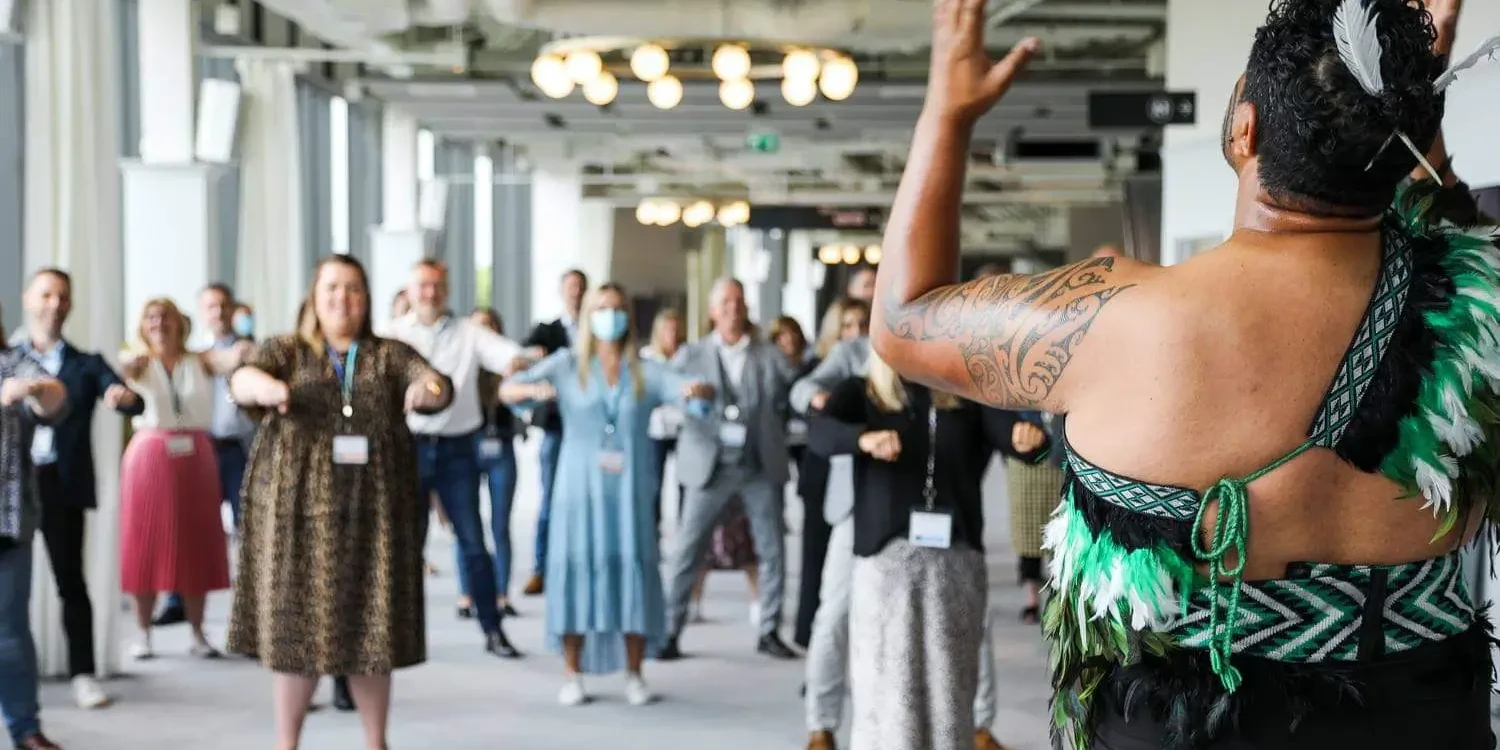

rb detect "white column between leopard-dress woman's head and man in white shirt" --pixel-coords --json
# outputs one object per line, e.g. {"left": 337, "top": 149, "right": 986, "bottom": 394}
{"left": 369, "top": 107, "right": 428, "bottom": 330}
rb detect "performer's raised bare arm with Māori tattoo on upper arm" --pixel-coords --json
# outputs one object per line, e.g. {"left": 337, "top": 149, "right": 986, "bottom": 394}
{"left": 870, "top": 0, "right": 1128, "bottom": 411}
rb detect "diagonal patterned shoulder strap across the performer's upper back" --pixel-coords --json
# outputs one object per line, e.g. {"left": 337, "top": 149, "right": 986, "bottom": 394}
{"left": 1308, "top": 231, "right": 1412, "bottom": 449}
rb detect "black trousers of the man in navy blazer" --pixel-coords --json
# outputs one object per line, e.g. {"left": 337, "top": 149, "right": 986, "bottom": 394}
{"left": 36, "top": 465, "right": 95, "bottom": 677}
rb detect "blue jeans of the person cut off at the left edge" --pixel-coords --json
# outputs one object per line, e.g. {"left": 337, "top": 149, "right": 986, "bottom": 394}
{"left": 0, "top": 542, "right": 42, "bottom": 744}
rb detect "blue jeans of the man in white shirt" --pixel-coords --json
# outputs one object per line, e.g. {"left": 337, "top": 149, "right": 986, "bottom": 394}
{"left": 417, "top": 435, "right": 500, "bottom": 633}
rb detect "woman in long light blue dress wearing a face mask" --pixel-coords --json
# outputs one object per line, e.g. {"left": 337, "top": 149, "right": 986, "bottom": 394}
{"left": 501, "top": 284, "right": 711, "bottom": 705}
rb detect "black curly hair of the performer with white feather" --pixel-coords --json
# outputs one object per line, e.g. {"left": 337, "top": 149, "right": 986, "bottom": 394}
{"left": 1241, "top": 0, "right": 1443, "bottom": 212}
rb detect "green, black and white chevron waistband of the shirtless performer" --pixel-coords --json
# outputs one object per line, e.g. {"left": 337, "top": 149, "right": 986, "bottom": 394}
{"left": 1169, "top": 554, "right": 1475, "bottom": 663}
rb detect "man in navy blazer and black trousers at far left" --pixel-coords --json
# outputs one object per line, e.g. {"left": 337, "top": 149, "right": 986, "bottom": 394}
{"left": 14, "top": 269, "right": 144, "bottom": 708}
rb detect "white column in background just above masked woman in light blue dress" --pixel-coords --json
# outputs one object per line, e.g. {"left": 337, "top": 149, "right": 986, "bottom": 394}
{"left": 531, "top": 162, "right": 615, "bottom": 321}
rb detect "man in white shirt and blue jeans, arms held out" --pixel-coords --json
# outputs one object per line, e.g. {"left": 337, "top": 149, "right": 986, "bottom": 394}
{"left": 387, "top": 258, "right": 521, "bottom": 659}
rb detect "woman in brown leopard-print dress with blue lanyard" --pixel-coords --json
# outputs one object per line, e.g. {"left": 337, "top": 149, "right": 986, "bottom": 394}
{"left": 230, "top": 255, "right": 453, "bottom": 750}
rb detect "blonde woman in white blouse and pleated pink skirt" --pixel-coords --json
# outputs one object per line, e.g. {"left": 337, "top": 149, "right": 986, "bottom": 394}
{"left": 120, "top": 297, "right": 251, "bottom": 659}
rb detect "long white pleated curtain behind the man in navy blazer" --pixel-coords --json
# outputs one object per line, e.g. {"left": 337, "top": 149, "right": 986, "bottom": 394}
{"left": 23, "top": 0, "right": 126, "bottom": 677}
